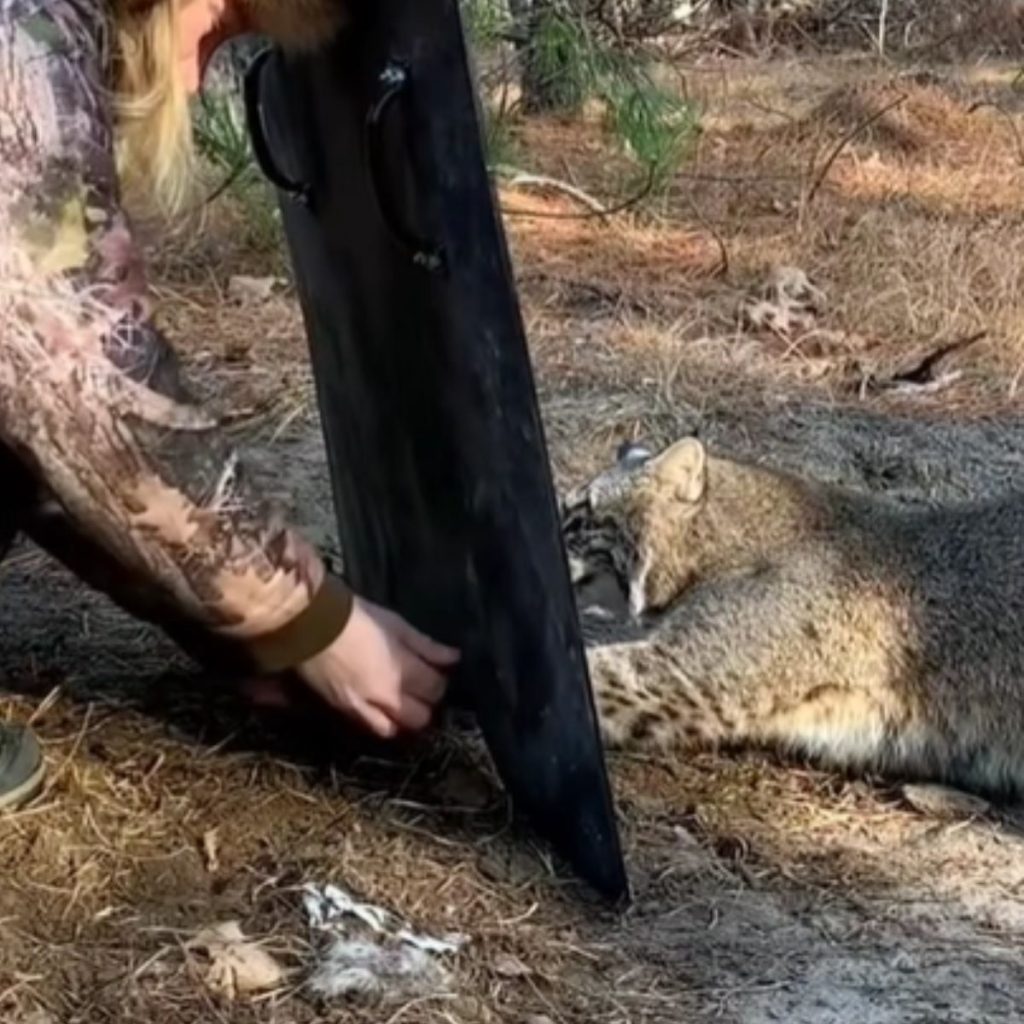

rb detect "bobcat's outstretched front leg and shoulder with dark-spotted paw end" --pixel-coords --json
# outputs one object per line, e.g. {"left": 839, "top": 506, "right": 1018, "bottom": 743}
{"left": 588, "top": 552, "right": 900, "bottom": 764}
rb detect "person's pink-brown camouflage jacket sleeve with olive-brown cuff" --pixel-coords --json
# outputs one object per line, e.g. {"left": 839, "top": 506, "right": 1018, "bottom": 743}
{"left": 0, "top": 0, "right": 350, "bottom": 669}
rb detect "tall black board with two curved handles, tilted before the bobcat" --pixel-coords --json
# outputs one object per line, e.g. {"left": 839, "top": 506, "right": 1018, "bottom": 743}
{"left": 246, "top": 0, "right": 628, "bottom": 900}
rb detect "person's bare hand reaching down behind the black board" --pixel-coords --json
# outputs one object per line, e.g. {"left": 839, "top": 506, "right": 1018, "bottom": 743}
{"left": 297, "top": 597, "right": 459, "bottom": 737}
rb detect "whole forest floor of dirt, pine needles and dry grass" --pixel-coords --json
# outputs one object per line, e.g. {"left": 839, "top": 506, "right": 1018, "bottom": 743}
{"left": 6, "top": 58, "right": 1024, "bottom": 1024}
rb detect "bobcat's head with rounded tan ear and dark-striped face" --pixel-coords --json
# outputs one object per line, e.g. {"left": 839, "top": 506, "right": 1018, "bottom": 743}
{"left": 562, "top": 437, "right": 708, "bottom": 618}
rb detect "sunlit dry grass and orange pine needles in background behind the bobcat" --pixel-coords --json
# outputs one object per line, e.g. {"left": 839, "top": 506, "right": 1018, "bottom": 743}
{"left": 507, "top": 63, "right": 1024, "bottom": 421}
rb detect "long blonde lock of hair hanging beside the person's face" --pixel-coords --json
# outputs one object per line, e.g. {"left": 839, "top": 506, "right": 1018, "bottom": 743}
{"left": 114, "top": 0, "right": 197, "bottom": 220}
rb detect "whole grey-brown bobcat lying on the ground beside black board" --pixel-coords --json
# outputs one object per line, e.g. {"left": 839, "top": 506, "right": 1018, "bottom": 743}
{"left": 562, "top": 438, "right": 1024, "bottom": 797}
